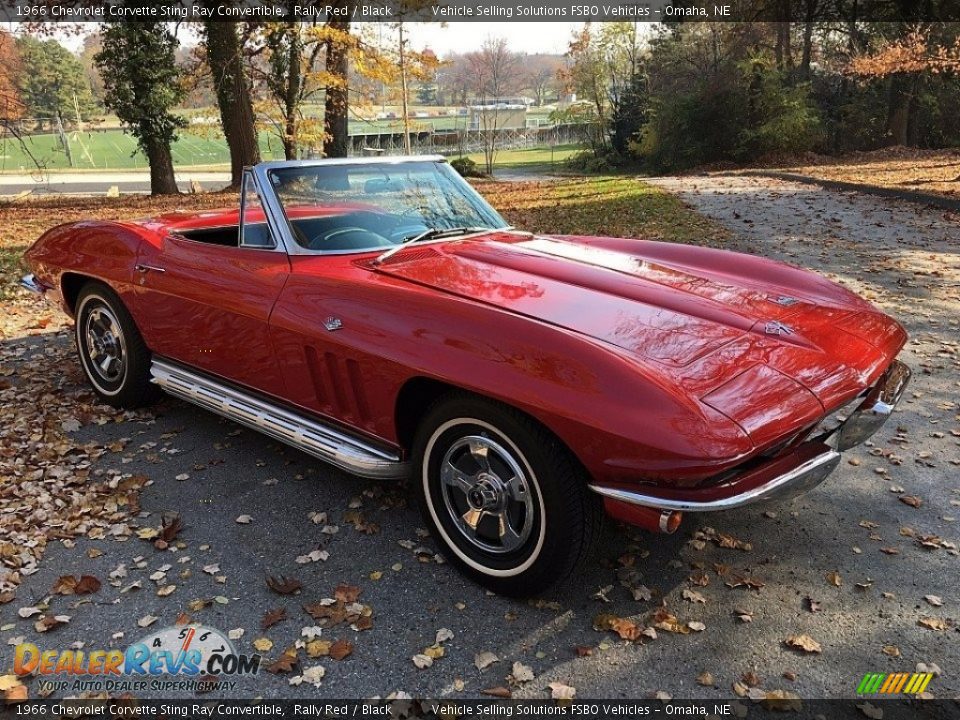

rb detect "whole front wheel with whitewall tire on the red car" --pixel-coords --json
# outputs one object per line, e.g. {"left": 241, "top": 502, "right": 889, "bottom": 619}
{"left": 414, "top": 394, "right": 603, "bottom": 596}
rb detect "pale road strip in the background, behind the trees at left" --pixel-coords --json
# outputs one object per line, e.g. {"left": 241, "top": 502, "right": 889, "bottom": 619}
{"left": 0, "top": 171, "right": 230, "bottom": 197}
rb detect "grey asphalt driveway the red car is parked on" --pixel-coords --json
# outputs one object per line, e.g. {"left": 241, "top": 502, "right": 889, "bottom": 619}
{"left": 0, "top": 177, "right": 960, "bottom": 698}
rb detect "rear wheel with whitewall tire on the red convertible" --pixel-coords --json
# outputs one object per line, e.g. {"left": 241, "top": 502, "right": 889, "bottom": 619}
{"left": 75, "top": 282, "right": 159, "bottom": 408}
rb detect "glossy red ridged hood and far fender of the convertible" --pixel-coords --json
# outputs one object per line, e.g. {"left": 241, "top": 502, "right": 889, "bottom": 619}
{"left": 377, "top": 233, "right": 905, "bottom": 424}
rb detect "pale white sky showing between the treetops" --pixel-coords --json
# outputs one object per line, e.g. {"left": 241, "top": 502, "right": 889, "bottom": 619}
{"left": 0, "top": 22, "right": 583, "bottom": 57}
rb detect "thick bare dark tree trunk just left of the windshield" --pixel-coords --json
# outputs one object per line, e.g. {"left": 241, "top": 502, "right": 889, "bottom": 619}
{"left": 204, "top": 20, "right": 260, "bottom": 188}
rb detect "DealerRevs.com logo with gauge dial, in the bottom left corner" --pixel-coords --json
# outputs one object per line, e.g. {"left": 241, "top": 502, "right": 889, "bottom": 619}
{"left": 14, "top": 625, "right": 260, "bottom": 692}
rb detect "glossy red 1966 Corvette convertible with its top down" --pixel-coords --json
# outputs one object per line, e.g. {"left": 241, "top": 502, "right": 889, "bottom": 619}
{"left": 23, "top": 157, "right": 910, "bottom": 594}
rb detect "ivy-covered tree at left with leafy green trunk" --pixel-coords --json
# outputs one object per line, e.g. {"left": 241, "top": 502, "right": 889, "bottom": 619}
{"left": 94, "top": 22, "right": 186, "bottom": 195}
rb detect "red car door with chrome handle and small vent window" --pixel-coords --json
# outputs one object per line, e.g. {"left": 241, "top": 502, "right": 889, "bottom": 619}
{"left": 136, "top": 176, "right": 290, "bottom": 395}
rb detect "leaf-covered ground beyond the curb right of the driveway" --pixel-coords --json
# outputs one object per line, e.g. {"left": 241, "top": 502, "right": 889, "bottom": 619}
{"left": 778, "top": 148, "right": 960, "bottom": 199}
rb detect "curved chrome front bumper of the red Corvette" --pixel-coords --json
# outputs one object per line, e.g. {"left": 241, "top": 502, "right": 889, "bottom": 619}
{"left": 590, "top": 360, "right": 911, "bottom": 512}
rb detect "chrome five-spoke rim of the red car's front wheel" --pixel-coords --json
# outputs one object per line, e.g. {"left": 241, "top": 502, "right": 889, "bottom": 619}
{"left": 440, "top": 435, "right": 535, "bottom": 554}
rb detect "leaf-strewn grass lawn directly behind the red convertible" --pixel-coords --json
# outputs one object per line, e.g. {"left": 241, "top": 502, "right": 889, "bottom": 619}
{"left": 0, "top": 177, "right": 726, "bottom": 296}
